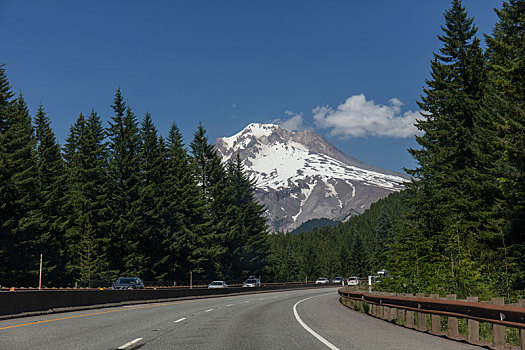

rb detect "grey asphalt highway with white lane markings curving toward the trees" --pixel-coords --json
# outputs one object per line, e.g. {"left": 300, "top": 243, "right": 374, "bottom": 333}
{"left": 0, "top": 288, "right": 476, "bottom": 350}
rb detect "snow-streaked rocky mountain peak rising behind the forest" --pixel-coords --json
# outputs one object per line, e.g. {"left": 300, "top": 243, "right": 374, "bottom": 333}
{"left": 215, "top": 123, "right": 408, "bottom": 231}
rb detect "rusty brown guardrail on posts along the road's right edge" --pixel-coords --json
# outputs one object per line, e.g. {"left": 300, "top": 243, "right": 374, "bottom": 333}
{"left": 338, "top": 288, "right": 525, "bottom": 350}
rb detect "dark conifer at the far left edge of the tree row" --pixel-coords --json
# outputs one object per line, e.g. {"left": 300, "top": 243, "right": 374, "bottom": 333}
{"left": 1, "top": 94, "right": 42, "bottom": 285}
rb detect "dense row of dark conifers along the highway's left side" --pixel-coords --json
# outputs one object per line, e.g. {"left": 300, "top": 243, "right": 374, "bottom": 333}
{"left": 0, "top": 72, "right": 269, "bottom": 286}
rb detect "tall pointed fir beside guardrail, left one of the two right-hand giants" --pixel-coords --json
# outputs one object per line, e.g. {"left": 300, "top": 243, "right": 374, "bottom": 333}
{"left": 408, "top": 0, "right": 484, "bottom": 294}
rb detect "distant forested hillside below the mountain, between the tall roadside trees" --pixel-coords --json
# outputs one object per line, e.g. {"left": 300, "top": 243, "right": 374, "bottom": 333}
{"left": 268, "top": 191, "right": 409, "bottom": 281}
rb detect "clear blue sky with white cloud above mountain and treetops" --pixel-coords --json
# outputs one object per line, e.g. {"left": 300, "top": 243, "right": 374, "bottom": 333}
{"left": 0, "top": 0, "right": 501, "bottom": 171}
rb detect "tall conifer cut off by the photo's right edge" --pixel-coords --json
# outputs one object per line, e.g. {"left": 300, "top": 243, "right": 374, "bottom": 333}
{"left": 478, "top": 0, "right": 525, "bottom": 295}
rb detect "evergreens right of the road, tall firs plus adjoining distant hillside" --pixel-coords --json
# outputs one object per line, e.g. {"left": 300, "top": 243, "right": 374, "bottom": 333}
{"left": 272, "top": 0, "right": 525, "bottom": 297}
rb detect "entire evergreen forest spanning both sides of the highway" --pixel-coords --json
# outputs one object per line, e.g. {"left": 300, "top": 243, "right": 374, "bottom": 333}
{"left": 0, "top": 0, "right": 525, "bottom": 298}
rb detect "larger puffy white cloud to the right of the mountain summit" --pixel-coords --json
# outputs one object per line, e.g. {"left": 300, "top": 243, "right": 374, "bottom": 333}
{"left": 314, "top": 94, "right": 421, "bottom": 138}
